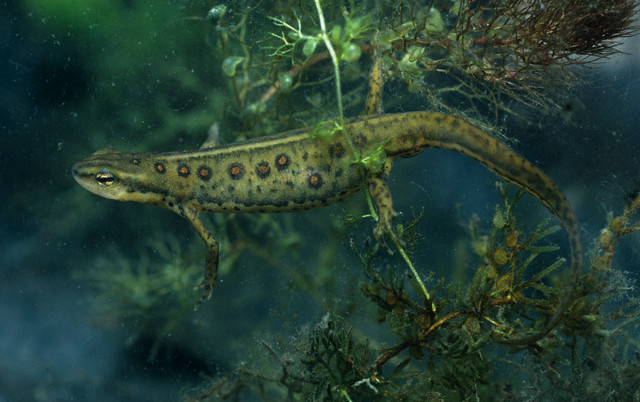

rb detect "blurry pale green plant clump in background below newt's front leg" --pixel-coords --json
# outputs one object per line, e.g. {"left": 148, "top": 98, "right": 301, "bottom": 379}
{"left": 74, "top": 234, "right": 200, "bottom": 361}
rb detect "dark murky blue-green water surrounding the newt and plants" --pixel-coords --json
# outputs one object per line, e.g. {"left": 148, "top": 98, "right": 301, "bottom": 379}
{"left": 0, "top": 0, "right": 640, "bottom": 401}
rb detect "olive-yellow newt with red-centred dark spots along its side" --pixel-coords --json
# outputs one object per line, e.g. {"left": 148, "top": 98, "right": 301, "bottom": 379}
{"left": 72, "top": 112, "right": 582, "bottom": 345}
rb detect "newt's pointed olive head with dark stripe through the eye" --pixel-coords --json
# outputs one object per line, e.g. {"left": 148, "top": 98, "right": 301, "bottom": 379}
{"left": 71, "top": 148, "right": 163, "bottom": 203}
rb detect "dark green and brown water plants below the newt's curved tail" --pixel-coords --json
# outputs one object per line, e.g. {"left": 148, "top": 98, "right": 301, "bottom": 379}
{"left": 192, "top": 186, "right": 640, "bottom": 400}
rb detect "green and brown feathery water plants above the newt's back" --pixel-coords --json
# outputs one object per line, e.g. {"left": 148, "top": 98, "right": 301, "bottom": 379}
{"left": 201, "top": 0, "right": 636, "bottom": 133}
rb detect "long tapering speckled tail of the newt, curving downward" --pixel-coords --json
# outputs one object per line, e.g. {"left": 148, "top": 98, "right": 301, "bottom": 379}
{"left": 380, "top": 112, "right": 582, "bottom": 345}
